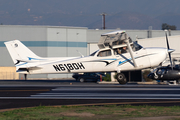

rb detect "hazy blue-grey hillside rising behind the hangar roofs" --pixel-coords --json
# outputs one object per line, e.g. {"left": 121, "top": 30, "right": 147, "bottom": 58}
{"left": 0, "top": 0, "right": 180, "bottom": 29}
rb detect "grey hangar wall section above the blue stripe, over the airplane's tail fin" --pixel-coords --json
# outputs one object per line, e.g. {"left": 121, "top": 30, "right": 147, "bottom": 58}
{"left": 0, "top": 25, "right": 46, "bottom": 41}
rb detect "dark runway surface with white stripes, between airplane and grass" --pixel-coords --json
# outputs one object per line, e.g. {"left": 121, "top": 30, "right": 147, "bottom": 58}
{"left": 0, "top": 80, "right": 180, "bottom": 109}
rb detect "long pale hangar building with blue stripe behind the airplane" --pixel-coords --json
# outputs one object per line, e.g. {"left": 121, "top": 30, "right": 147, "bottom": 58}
{"left": 0, "top": 25, "right": 180, "bottom": 79}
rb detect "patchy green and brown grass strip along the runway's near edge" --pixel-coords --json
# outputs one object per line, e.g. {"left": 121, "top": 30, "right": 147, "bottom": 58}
{"left": 0, "top": 105, "right": 180, "bottom": 120}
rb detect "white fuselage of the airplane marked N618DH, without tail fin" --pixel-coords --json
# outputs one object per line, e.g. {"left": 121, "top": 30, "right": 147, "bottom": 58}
{"left": 21, "top": 48, "right": 167, "bottom": 74}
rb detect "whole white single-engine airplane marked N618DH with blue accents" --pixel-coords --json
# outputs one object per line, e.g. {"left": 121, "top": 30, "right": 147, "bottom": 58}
{"left": 5, "top": 30, "right": 173, "bottom": 84}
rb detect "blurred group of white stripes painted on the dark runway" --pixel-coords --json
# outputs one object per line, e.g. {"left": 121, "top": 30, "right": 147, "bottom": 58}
{"left": 28, "top": 87, "right": 180, "bottom": 99}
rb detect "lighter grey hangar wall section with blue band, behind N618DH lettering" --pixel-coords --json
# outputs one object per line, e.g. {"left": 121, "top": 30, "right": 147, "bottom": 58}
{"left": 47, "top": 27, "right": 87, "bottom": 79}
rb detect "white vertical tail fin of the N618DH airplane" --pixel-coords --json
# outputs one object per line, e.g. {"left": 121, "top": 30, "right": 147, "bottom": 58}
{"left": 4, "top": 40, "right": 40, "bottom": 64}
